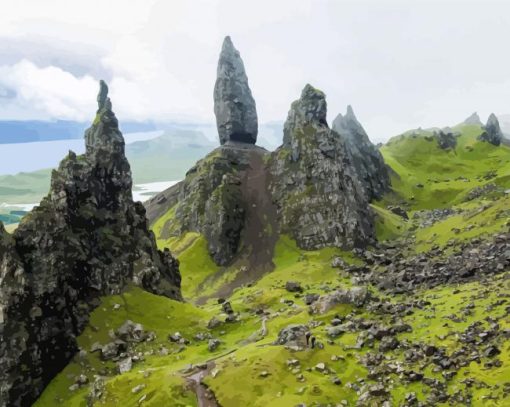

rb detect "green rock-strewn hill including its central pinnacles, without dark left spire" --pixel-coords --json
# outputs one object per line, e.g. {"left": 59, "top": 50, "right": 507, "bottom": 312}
{"left": 29, "top": 39, "right": 510, "bottom": 407}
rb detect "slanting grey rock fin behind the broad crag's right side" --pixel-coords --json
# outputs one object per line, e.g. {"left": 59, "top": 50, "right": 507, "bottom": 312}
{"left": 332, "top": 106, "right": 390, "bottom": 200}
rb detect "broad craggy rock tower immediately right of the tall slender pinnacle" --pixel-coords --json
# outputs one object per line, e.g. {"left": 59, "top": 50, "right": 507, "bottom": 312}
{"left": 269, "top": 85, "right": 374, "bottom": 249}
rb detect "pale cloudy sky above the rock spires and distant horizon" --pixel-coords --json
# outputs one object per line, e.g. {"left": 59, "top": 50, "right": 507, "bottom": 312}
{"left": 0, "top": 0, "right": 510, "bottom": 141}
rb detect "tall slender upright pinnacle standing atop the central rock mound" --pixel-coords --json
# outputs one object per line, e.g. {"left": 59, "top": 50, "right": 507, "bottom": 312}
{"left": 214, "top": 37, "right": 258, "bottom": 145}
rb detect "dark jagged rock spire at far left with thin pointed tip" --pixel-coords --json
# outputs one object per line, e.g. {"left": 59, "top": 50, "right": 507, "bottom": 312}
{"left": 0, "top": 82, "right": 181, "bottom": 407}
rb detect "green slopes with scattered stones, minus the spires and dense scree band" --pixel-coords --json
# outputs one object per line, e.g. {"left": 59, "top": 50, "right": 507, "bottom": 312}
{"left": 36, "top": 125, "right": 510, "bottom": 407}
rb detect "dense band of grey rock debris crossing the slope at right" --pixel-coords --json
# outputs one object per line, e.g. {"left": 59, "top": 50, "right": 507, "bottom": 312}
{"left": 349, "top": 233, "right": 510, "bottom": 293}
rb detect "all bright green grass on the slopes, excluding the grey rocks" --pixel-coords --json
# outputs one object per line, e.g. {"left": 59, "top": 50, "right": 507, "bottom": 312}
{"left": 36, "top": 126, "right": 510, "bottom": 407}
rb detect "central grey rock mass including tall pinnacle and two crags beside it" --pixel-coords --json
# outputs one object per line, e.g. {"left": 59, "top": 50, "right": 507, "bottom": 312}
{"left": 146, "top": 37, "right": 389, "bottom": 266}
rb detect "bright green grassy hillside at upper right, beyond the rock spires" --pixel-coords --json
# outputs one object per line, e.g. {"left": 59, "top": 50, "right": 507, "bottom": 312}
{"left": 381, "top": 125, "right": 510, "bottom": 209}
